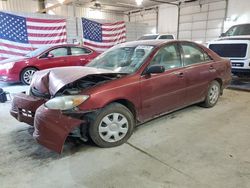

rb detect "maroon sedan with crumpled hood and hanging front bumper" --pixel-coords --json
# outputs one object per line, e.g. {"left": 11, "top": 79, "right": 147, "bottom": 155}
{"left": 11, "top": 40, "right": 231, "bottom": 152}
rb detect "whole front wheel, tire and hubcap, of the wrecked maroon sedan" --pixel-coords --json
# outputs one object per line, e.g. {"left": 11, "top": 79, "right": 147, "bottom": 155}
{"left": 89, "top": 103, "right": 135, "bottom": 148}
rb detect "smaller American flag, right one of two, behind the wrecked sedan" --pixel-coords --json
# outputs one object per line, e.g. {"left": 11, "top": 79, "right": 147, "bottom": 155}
{"left": 82, "top": 18, "right": 126, "bottom": 52}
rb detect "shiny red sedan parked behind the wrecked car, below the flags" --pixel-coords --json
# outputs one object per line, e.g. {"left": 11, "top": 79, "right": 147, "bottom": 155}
{"left": 0, "top": 44, "right": 99, "bottom": 85}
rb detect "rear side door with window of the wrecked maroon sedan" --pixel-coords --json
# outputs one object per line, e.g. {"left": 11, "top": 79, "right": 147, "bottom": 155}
{"left": 181, "top": 42, "right": 216, "bottom": 104}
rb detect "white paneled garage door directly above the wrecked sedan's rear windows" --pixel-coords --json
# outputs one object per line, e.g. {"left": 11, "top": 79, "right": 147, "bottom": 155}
{"left": 179, "top": 1, "right": 226, "bottom": 42}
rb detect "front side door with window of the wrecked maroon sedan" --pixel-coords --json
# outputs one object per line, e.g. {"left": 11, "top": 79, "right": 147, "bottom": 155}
{"left": 140, "top": 43, "right": 186, "bottom": 119}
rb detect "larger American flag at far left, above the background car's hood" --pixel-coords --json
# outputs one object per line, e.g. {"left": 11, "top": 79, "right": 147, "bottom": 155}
{"left": 0, "top": 12, "right": 67, "bottom": 61}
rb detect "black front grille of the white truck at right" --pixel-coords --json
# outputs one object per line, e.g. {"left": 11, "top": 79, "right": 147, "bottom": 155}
{"left": 209, "top": 44, "right": 247, "bottom": 58}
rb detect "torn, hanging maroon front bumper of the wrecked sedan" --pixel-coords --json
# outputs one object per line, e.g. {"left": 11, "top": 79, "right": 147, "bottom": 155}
{"left": 10, "top": 93, "right": 86, "bottom": 153}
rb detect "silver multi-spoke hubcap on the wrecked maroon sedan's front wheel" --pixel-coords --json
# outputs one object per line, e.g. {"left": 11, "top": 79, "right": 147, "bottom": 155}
{"left": 98, "top": 113, "right": 128, "bottom": 142}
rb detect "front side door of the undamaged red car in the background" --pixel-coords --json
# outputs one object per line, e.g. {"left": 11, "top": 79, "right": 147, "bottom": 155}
{"left": 38, "top": 47, "right": 69, "bottom": 69}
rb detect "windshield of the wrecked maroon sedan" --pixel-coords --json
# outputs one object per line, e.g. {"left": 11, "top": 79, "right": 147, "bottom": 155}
{"left": 87, "top": 45, "right": 154, "bottom": 74}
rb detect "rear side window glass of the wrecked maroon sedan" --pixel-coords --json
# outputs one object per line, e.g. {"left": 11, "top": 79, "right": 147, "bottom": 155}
{"left": 182, "top": 44, "right": 211, "bottom": 65}
